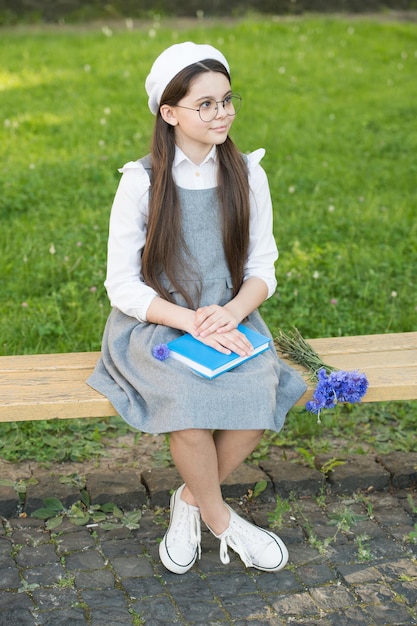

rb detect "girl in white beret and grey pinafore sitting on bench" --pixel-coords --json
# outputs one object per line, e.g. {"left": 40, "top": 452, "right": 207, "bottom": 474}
{"left": 89, "top": 42, "right": 306, "bottom": 574}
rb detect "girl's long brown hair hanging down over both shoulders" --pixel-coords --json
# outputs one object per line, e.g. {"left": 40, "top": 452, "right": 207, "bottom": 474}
{"left": 142, "top": 59, "right": 250, "bottom": 308}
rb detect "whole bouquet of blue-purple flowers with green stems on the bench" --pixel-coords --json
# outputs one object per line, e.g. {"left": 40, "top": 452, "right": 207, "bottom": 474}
{"left": 275, "top": 328, "right": 368, "bottom": 422}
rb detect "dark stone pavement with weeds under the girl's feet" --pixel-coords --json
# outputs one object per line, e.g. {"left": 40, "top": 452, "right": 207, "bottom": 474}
{"left": 0, "top": 453, "right": 417, "bottom": 626}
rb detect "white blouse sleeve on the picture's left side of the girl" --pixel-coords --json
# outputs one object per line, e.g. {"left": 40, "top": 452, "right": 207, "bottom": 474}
{"left": 104, "top": 162, "right": 157, "bottom": 321}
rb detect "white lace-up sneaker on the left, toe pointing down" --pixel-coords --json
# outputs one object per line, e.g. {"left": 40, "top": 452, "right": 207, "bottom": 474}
{"left": 159, "top": 485, "right": 201, "bottom": 574}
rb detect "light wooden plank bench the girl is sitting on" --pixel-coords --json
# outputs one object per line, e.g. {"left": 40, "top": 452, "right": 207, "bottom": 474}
{"left": 0, "top": 332, "right": 417, "bottom": 422}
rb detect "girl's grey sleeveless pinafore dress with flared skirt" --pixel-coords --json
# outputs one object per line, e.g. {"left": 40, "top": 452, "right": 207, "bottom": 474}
{"left": 87, "top": 183, "right": 306, "bottom": 434}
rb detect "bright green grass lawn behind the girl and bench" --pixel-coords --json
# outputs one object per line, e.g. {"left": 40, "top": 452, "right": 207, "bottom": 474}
{"left": 0, "top": 17, "right": 417, "bottom": 464}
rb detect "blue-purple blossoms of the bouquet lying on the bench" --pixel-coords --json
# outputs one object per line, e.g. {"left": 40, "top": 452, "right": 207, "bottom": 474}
{"left": 306, "top": 367, "right": 368, "bottom": 414}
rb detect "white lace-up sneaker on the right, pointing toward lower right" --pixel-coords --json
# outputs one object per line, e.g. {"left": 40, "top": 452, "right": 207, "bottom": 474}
{"left": 209, "top": 504, "right": 288, "bottom": 572}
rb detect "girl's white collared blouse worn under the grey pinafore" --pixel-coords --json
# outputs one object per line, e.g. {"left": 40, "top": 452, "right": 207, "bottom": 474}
{"left": 104, "top": 146, "right": 278, "bottom": 322}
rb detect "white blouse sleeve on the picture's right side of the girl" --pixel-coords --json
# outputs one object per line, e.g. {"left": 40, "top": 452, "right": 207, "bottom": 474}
{"left": 244, "top": 149, "right": 278, "bottom": 298}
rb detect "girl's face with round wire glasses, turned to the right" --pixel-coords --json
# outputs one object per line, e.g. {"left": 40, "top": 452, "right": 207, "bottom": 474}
{"left": 161, "top": 72, "right": 234, "bottom": 165}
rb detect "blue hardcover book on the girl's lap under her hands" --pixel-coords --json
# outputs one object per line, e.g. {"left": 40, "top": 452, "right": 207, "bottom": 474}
{"left": 168, "top": 324, "right": 271, "bottom": 378}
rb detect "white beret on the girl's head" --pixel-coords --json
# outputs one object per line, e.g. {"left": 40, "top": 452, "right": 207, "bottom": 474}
{"left": 145, "top": 41, "right": 230, "bottom": 115}
